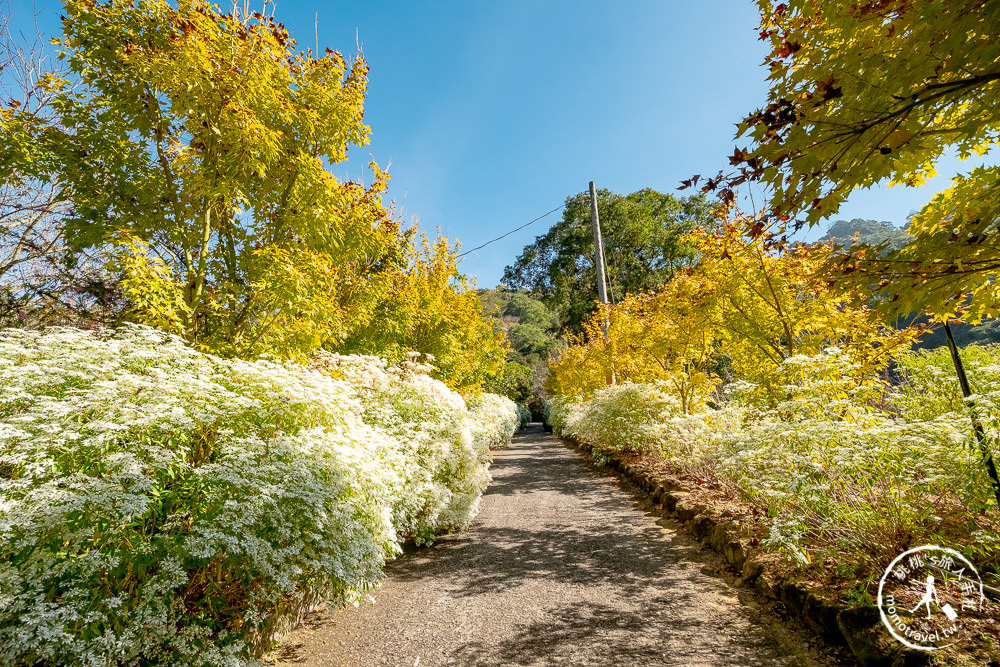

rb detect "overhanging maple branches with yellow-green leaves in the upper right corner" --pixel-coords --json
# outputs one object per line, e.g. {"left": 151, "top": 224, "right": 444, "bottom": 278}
{"left": 706, "top": 0, "right": 1000, "bottom": 322}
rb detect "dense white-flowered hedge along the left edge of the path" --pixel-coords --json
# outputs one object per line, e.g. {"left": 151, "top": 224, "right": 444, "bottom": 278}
{"left": 0, "top": 326, "right": 516, "bottom": 665}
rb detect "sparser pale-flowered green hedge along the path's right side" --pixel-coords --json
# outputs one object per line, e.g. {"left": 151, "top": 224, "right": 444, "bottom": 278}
{"left": 548, "top": 348, "right": 1000, "bottom": 563}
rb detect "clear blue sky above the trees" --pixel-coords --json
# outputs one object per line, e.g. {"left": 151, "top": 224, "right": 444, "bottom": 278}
{"left": 7, "top": 0, "right": 984, "bottom": 287}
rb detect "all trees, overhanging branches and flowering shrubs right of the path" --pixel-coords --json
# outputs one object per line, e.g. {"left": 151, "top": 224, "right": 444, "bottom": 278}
{"left": 546, "top": 0, "right": 1000, "bottom": 648}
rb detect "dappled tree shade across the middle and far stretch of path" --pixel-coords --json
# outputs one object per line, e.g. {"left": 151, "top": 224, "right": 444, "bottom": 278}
{"left": 378, "top": 427, "right": 702, "bottom": 596}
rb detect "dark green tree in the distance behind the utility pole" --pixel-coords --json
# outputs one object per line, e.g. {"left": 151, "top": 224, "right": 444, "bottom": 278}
{"left": 503, "top": 188, "right": 715, "bottom": 332}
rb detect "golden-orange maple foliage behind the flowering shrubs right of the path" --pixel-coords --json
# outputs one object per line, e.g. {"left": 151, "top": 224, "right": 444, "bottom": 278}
{"left": 549, "top": 219, "right": 916, "bottom": 412}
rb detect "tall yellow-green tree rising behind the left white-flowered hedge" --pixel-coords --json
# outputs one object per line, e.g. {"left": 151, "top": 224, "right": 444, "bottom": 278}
{"left": 0, "top": 0, "right": 396, "bottom": 356}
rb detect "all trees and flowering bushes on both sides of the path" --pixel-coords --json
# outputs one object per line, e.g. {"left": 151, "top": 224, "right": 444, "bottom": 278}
{"left": 0, "top": 0, "right": 1000, "bottom": 665}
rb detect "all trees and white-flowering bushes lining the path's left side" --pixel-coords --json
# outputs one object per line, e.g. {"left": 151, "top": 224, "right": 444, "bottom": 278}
{"left": 0, "top": 0, "right": 523, "bottom": 665}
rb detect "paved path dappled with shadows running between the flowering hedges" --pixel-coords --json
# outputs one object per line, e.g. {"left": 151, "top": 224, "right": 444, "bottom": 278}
{"left": 276, "top": 425, "right": 827, "bottom": 667}
